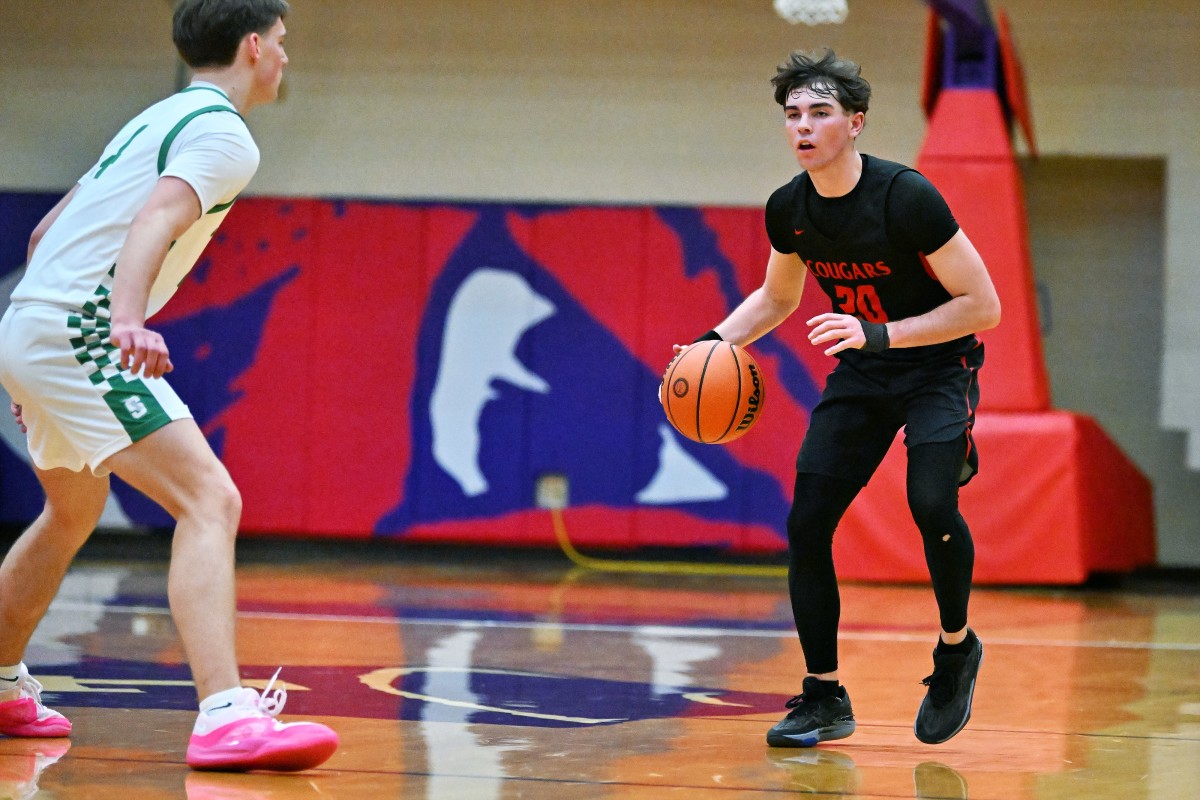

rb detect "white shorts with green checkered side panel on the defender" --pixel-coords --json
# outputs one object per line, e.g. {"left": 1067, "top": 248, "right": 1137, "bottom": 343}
{"left": 0, "top": 305, "right": 192, "bottom": 475}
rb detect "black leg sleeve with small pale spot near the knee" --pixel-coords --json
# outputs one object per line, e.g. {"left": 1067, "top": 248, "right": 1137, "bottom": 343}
{"left": 908, "top": 439, "right": 974, "bottom": 631}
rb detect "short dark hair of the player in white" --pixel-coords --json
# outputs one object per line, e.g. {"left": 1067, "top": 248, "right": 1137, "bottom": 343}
{"left": 172, "top": 0, "right": 288, "bottom": 70}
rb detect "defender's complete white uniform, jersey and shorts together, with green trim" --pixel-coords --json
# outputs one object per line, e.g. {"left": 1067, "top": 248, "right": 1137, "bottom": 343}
{"left": 0, "top": 88, "right": 258, "bottom": 475}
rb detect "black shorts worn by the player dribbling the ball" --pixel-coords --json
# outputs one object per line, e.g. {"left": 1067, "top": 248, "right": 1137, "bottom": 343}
{"left": 796, "top": 342, "right": 983, "bottom": 486}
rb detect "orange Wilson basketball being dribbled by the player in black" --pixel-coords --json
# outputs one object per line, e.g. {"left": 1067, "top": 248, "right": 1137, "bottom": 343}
{"left": 659, "top": 341, "right": 766, "bottom": 445}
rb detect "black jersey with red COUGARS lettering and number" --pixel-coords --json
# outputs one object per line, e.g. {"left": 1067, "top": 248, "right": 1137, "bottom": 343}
{"left": 767, "top": 156, "right": 976, "bottom": 361}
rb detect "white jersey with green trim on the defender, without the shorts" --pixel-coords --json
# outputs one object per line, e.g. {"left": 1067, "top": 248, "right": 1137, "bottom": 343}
{"left": 12, "top": 82, "right": 258, "bottom": 319}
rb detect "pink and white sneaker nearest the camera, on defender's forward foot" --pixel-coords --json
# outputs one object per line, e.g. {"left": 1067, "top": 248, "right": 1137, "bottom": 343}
{"left": 187, "top": 670, "right": 337, "bottom": 772}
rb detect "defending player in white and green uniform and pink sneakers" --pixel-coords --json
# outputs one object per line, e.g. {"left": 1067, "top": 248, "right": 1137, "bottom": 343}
{"left": 0, "top": 0, "right": 337, "bottom": 770}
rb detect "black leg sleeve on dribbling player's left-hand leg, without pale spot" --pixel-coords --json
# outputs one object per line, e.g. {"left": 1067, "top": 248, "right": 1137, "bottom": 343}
{"left": 787, "top": 473, "right": 862, "bottom": 674}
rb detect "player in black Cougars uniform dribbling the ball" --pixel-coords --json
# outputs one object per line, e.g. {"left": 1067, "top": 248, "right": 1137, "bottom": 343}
{"left": 677, "top": 50, "right": 1000, "bottom": 747}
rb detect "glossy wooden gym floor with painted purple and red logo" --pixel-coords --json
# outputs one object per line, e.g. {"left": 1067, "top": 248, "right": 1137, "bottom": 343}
{"left": 0, "top": 535, "right": 1200, "bottom": 800}
